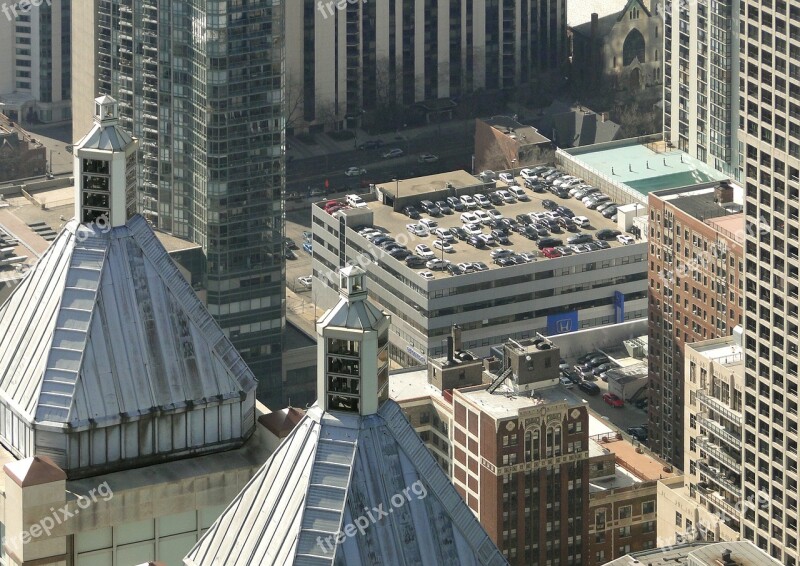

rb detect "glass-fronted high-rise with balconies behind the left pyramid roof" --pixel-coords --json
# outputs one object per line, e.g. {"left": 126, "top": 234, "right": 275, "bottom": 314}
{"left": 73, "top": 0, "right": 285, "bottom": 404}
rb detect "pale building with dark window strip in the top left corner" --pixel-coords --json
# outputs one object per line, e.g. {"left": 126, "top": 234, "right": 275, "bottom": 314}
{"left": 0, "top": 0, "right": 70, "bottom": 123}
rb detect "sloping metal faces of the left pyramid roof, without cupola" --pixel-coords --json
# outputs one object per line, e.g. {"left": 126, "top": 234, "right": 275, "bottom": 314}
{"left": 0, "top": 215, "right": 256, "bottom": 432}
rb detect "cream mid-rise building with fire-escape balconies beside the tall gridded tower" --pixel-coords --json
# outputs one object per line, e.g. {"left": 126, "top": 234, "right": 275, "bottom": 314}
{"left": 658, "top": 327, "right": 744, "bottom": 544}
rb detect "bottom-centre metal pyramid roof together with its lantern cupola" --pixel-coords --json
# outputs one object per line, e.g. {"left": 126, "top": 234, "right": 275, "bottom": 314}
{"left": 184, "top": 267, "right": 507, "bottom": 566}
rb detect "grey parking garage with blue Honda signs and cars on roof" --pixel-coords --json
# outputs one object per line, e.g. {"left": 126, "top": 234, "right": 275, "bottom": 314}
{"left": 312, "top": 171, "right": 647, "bottom": 366}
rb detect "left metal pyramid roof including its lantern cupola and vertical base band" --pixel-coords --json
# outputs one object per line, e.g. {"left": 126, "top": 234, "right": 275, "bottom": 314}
{"left": 0, "top": 99, "right": 256, "bottom": 478}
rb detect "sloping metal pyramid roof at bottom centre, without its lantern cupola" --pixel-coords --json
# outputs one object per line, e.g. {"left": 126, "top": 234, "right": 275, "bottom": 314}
{"left": 184, "top": 401, "right": 507, "bottom": 566}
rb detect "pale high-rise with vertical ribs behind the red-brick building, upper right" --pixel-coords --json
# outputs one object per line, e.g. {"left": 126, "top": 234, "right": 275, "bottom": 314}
{"left": 658, "top": 0, "right": 742, "bottom": 180}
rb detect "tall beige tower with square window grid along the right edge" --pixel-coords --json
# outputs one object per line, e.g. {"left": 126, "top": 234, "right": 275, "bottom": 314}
{"left": 736, "top": 0, "right": 800, "bottom": 566}
